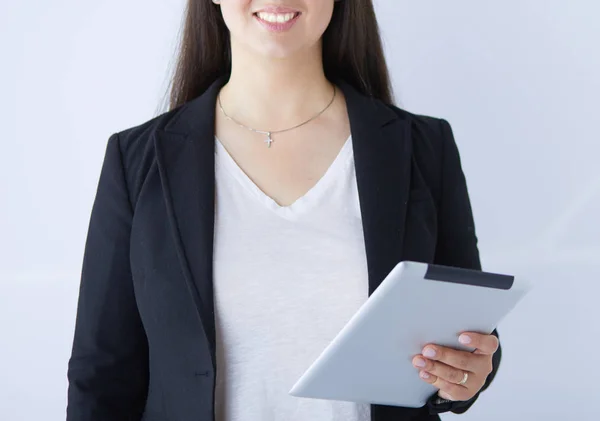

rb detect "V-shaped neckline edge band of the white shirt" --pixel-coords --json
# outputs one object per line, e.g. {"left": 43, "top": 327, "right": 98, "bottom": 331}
{"left": 215, "top": 135, "right": 352, "bottom": 219}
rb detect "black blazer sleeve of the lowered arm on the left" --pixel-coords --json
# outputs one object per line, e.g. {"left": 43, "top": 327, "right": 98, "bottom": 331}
{"left": 67, "top": 133, "right": 148, "bottom": 421}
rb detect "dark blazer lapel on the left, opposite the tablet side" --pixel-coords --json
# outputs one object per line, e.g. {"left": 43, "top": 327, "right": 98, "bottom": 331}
{"left": 155, "top": 78, "right": 225, "bottom": 369}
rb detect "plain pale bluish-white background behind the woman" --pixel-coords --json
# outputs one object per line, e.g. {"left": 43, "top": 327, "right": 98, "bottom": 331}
{"left": 0, "top": 0, "right": 600, "bottom": 421}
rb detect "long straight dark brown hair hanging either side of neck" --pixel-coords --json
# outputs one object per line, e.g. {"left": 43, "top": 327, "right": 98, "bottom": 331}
{"left": 162, "top": 0, "right": 393, "bottom": 110}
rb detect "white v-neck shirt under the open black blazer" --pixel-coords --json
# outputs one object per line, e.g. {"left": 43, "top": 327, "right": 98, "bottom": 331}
{"left": 213, "top": 137, "right": 370, "bottom": 421}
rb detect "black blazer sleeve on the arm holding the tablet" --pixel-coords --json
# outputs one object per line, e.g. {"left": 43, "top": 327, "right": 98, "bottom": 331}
{"left": 428, "top": 119, "right": 502, "bottom": 414}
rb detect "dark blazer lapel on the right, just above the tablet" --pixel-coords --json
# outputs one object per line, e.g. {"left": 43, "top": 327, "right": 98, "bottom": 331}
{"left": 338, "top": 82, "right": 412, "bottom": 294}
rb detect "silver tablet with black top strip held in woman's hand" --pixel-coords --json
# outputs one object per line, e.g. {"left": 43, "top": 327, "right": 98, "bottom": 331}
{"left": 289, "top": 261, "right": 530, "bottom": 408}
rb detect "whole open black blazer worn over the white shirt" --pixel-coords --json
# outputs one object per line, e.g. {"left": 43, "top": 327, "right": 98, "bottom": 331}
{"left": 67, "top": 78, "right": 500, "bottom": 421}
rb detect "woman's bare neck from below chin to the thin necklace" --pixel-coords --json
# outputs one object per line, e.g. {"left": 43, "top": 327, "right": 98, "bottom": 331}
{"left": 220, "top": 44, "right": 333, "bottom": 130}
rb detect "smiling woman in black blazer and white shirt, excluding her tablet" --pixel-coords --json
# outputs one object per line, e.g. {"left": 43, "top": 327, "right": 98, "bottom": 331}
{"left": 67, "top": 0, "right": 500, "bottom": 421}
